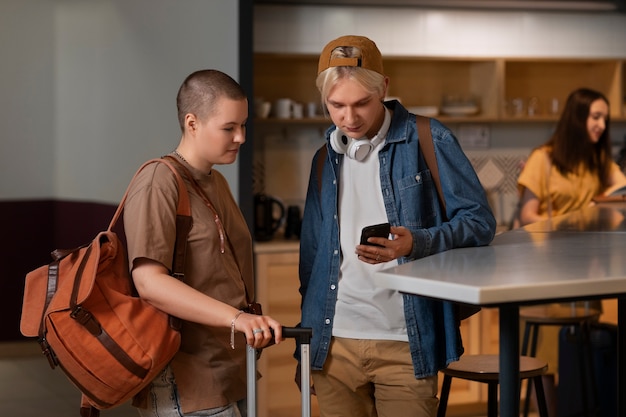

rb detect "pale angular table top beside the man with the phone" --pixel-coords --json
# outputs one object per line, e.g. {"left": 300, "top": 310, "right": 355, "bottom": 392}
{"left": 375, "top": 205, "right": 626, "bottom": 306}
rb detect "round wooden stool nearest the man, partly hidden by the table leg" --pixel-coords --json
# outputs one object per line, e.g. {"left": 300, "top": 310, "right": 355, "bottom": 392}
{"left": 437, "top": 355, "right": 548, "bottom": 417}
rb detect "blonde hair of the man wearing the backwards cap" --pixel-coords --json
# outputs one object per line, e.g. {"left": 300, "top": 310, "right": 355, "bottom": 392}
{"left": 315, "top": 46, "right": 385, "bottom": 103}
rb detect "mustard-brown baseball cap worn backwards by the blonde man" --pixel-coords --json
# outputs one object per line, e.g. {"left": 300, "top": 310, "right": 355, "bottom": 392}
{"left": 317, "top": 35, "right": 385, "bottom": 75}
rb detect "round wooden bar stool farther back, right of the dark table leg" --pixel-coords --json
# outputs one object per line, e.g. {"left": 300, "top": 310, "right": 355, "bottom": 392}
{"left": 520, "top": 302, "right": 601, "bottom": 417}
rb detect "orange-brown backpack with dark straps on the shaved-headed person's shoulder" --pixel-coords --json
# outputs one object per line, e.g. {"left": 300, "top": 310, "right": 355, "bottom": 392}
{"left": 20, "top": 158, "right": 191, "bottom": 417}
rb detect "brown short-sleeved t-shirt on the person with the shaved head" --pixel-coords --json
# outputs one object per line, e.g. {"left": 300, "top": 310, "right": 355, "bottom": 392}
{"left": 124, "top": 157, "right": 254, "bottom": 413}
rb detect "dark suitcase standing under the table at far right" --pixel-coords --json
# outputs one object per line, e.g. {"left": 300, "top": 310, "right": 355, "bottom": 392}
{"left": 557, "top": 323, "right": 618, "bottom": 417}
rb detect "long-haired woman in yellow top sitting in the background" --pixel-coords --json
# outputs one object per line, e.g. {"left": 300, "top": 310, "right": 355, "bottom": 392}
{"left": 518, "top": 88, "right": 626, "bottom": 226}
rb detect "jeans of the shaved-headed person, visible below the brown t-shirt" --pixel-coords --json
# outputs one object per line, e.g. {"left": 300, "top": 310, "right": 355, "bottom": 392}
{"left": 137, "top": 366, "right": 247, "bottom": 417}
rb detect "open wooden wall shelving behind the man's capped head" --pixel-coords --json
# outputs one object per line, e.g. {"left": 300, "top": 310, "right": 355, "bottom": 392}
{"left": 254, "top": 53, "right": 626, "bottom": 124}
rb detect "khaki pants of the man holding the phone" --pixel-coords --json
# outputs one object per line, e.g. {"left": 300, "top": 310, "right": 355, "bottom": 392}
{"left": 312, "top": 337, "right": 439, "bottom": 417}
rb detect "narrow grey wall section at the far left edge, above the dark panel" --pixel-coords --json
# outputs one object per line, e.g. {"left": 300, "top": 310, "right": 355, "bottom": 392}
{"left": 0, "top": 0, "right": 55, "bottom": 199}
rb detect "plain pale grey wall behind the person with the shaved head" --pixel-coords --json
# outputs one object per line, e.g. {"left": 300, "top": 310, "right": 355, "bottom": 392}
{"left": 0, "top": 0, "right": 239, "bottom": 203}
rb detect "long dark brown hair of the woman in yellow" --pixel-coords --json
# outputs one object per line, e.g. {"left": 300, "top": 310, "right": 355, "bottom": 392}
{"left": 546, "top": 88, "right": 612, "bottom": 186}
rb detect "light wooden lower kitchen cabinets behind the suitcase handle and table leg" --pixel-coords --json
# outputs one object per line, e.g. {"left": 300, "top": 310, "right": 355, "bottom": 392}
{"left": 255, "top": 241, "right": 498, "bottom": 417}
